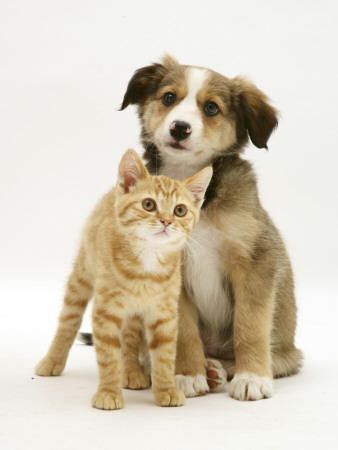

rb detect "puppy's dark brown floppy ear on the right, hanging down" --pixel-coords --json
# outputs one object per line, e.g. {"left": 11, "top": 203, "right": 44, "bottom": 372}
{"left": 233, "top": 77, "right": 278, "bottom": 149}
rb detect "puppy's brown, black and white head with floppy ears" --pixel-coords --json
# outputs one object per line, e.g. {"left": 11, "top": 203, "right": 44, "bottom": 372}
{"left": 121, "top": 56, "right": 277, "bottom": 170}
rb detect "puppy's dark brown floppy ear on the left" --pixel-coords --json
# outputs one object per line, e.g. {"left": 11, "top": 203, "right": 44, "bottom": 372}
{"left": 120, "top": 63, "right": 163, "bottom": 111}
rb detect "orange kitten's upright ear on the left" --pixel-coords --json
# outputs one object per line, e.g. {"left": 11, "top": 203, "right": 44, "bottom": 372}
{"left": 117, "top": 150, "right": 149, "bottom": 193}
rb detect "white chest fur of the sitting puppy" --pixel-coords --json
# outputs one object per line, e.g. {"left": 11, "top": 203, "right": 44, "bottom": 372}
{"left": 184, "top": 217, "right": 231, "bottom": 332}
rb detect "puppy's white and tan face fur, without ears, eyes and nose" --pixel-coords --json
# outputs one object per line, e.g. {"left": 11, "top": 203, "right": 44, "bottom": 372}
{"left": 148, "top": 67, "right": 235, "bottom": 179}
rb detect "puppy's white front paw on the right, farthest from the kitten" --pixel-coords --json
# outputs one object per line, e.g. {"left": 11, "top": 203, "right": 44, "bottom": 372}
{"left": 229, "top": 372, "right": 273, "bottom": 400}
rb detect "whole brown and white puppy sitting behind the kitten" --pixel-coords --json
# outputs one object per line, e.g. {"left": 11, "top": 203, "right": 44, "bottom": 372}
{"left": 121, "top": 56, "right": 302, "bottom": 400}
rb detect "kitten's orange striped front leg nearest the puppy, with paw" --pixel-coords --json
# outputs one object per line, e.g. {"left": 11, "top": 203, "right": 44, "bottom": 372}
{"left": 146, "top": 310, "right": 185, "bottom": 406}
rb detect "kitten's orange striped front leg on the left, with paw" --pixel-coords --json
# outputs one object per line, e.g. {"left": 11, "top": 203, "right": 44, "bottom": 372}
{"left": 92, "top": 297, "right": 124, "bottom": 410}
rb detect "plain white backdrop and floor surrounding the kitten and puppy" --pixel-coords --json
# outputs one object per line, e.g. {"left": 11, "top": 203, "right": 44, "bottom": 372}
{"left": 0, "top": 0, "right": 338, "bottom": 450}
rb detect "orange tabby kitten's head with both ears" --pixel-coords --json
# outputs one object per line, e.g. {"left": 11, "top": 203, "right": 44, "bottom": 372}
{"left": 116, "top": 150, "right": 212, "bottom": 246}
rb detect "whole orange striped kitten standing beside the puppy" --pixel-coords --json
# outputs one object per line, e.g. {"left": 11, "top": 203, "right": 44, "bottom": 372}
{"left": 35, "top": 150, "right": 212, "bottom": 409}
